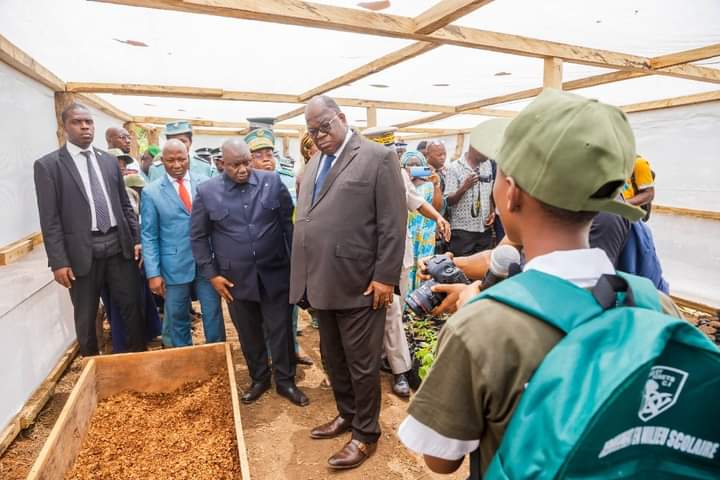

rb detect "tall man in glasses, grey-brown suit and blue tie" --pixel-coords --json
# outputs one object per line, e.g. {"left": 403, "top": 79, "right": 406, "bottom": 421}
{"left": 290, "top": 96, "right": 407, "bottom": 469}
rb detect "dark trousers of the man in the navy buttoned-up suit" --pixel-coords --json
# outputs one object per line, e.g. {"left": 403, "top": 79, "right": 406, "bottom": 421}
{"left": 228, "top": 298, "right": 297, "bottom": 386}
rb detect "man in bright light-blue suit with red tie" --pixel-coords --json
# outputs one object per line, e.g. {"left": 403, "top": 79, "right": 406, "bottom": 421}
{"left": 140, "top": 139, "right": 225, "bottom": 347}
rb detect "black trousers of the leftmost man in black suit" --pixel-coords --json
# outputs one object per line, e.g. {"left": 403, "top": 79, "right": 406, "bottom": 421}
{"left": 70, "top": 232, "right": 146, "bottom": 356}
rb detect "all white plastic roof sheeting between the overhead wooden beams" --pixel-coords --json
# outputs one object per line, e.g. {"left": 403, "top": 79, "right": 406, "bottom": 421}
{"left": 0, "top": 0, "right": 720, "bottom": 128}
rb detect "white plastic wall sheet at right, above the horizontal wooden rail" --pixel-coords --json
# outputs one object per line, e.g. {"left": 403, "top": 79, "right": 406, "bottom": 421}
{"left": 629, "top": 102, "right": 720, "bottom": 210}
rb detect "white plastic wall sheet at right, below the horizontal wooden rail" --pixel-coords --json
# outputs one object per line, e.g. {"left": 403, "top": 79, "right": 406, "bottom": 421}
{"left": 649, "top": 213, "right": 720, "bottom": 306}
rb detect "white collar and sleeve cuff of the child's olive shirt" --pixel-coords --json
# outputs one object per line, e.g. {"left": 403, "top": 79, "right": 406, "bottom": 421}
{"left": 398, "top": 248, "right": 615, "bottom": 460}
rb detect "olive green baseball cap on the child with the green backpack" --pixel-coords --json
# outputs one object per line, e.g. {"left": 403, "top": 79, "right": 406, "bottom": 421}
{"left": 496, "top": 89, "right": 645, "bottom": 221}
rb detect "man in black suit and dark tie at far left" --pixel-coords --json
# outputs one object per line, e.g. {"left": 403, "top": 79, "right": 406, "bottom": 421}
{"left": 35, "top": 103, "right": 145, "bottom": 356}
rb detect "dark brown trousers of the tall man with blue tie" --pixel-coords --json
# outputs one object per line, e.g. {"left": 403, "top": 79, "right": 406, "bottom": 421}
{"left": 317, "top": 307, "right": 385, "bottom": 443}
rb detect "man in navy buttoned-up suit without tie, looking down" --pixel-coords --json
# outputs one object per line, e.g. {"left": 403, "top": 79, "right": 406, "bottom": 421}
{"left": 191, "top": 139, "right": 309, "bottom": 406}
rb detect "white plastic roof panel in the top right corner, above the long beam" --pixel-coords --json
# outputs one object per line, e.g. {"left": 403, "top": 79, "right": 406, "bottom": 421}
{"left": 456, "top": 0, "right": 720, "bottom": 57}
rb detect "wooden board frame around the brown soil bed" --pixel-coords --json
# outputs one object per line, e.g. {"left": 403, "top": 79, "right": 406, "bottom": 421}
{"left": 27, "top": 343, "right": 250, "bottom": 480}
